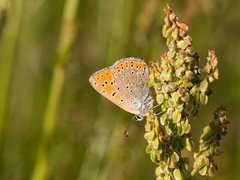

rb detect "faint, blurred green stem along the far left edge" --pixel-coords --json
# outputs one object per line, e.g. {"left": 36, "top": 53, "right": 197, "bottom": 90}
{"left": 0, "top": 0, "right": 26, "bottom": 174}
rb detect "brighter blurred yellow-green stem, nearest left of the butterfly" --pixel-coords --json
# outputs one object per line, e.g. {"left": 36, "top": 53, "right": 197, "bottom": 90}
{"left": 32, "top": 0, "right": 79, "bottom": 180}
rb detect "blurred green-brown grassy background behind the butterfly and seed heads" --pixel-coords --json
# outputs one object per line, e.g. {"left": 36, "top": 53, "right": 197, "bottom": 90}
{"left": 0, "top": 0, "right": 240, "bottom": 180}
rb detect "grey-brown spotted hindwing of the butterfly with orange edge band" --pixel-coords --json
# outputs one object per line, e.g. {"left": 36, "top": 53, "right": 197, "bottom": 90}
{"left": 112, "top": 58, "right": 149, "bottom": 115}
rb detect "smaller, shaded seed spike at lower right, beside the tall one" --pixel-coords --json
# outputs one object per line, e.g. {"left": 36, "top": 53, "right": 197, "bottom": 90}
{"left": 191, "top": 106, "right": 230, "bottom": 176}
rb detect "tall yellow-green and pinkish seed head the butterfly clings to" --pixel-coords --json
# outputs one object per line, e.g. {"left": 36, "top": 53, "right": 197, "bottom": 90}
{"left": 144, "top": 6, "right": 227, "bottom": 179}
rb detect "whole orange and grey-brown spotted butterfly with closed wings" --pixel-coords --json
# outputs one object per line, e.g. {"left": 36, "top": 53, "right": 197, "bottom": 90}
{"left": 89, "top": 58, "right": 153, "bottom": 120}
